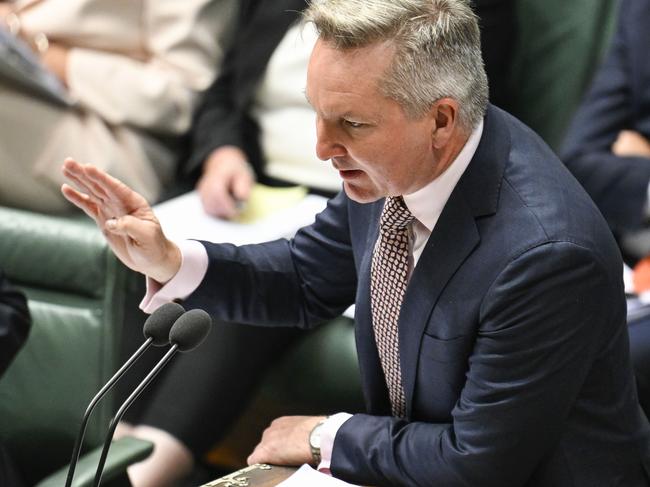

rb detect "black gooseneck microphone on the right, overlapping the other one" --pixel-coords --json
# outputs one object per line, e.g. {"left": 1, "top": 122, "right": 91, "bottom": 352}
{"left": 93, "top": 309, "right": 212, "bottom": 487}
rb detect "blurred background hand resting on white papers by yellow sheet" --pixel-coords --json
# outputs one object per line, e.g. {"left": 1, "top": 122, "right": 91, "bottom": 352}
{"left": 197, "top": 146, "right": 255, "bottom": 219}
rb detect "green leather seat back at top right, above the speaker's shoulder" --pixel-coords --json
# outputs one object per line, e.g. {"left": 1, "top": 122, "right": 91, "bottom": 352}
{"left": 504, "top": 0, "right": 618, "bottom": 149}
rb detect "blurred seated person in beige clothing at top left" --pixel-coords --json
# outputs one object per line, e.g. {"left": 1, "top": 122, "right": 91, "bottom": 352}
{"left": 0, "top": 0, "right": 236, "bottom": 212}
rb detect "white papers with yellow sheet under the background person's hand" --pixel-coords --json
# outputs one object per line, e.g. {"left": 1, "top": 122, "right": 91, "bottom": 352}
{"left": 153, "top": 184, "right": 327, "bottom": 245}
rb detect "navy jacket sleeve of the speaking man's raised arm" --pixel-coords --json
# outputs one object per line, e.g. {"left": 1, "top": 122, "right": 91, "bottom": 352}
{"left": 185, "top": 194, "right": 357, "bottom": 328}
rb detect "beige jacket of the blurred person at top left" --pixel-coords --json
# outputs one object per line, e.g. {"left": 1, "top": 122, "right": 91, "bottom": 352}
{"left": 15, "top": 0, "right": 237, "bottom": 135}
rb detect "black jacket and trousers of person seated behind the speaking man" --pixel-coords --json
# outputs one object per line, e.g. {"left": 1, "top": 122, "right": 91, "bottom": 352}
{"left": 119, "top": 0, "right": 514, "bottom": 470}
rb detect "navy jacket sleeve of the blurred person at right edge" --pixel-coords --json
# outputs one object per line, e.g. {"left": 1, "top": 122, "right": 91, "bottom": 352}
{"left": 561, "top": 2, "right": 650, "bottom": 234}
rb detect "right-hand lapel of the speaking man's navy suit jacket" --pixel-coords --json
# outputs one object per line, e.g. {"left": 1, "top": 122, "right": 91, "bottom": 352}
{"left": 399, "top": 106, "right": 510, "bottom": 417}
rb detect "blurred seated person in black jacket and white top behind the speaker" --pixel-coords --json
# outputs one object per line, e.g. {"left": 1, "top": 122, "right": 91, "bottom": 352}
{"left": 115, "top": 0, "right": 513, "bottom": 487}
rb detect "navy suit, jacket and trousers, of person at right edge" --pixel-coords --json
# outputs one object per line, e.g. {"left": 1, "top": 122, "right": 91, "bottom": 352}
{"left": 561, "top": 0, "right": 650, "bottom": 414}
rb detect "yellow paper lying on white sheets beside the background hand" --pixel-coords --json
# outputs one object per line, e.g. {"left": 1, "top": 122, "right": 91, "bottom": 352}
{"left": 235, "top": 184, "right": 307, "bottom": 223}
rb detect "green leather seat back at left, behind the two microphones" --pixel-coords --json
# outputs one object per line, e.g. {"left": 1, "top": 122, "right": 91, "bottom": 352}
{"left": 0, "top": 208, "right": 130, "bottom": 483}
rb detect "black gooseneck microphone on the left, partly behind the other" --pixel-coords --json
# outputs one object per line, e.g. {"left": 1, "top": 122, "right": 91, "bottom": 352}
{"left": 65, "top": 303, "right": 185, "bottom": 487}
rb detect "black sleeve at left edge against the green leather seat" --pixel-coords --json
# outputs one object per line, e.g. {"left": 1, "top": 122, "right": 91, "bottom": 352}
{"left": 0, "top": 271, "right": 31, "bottom": 374}
